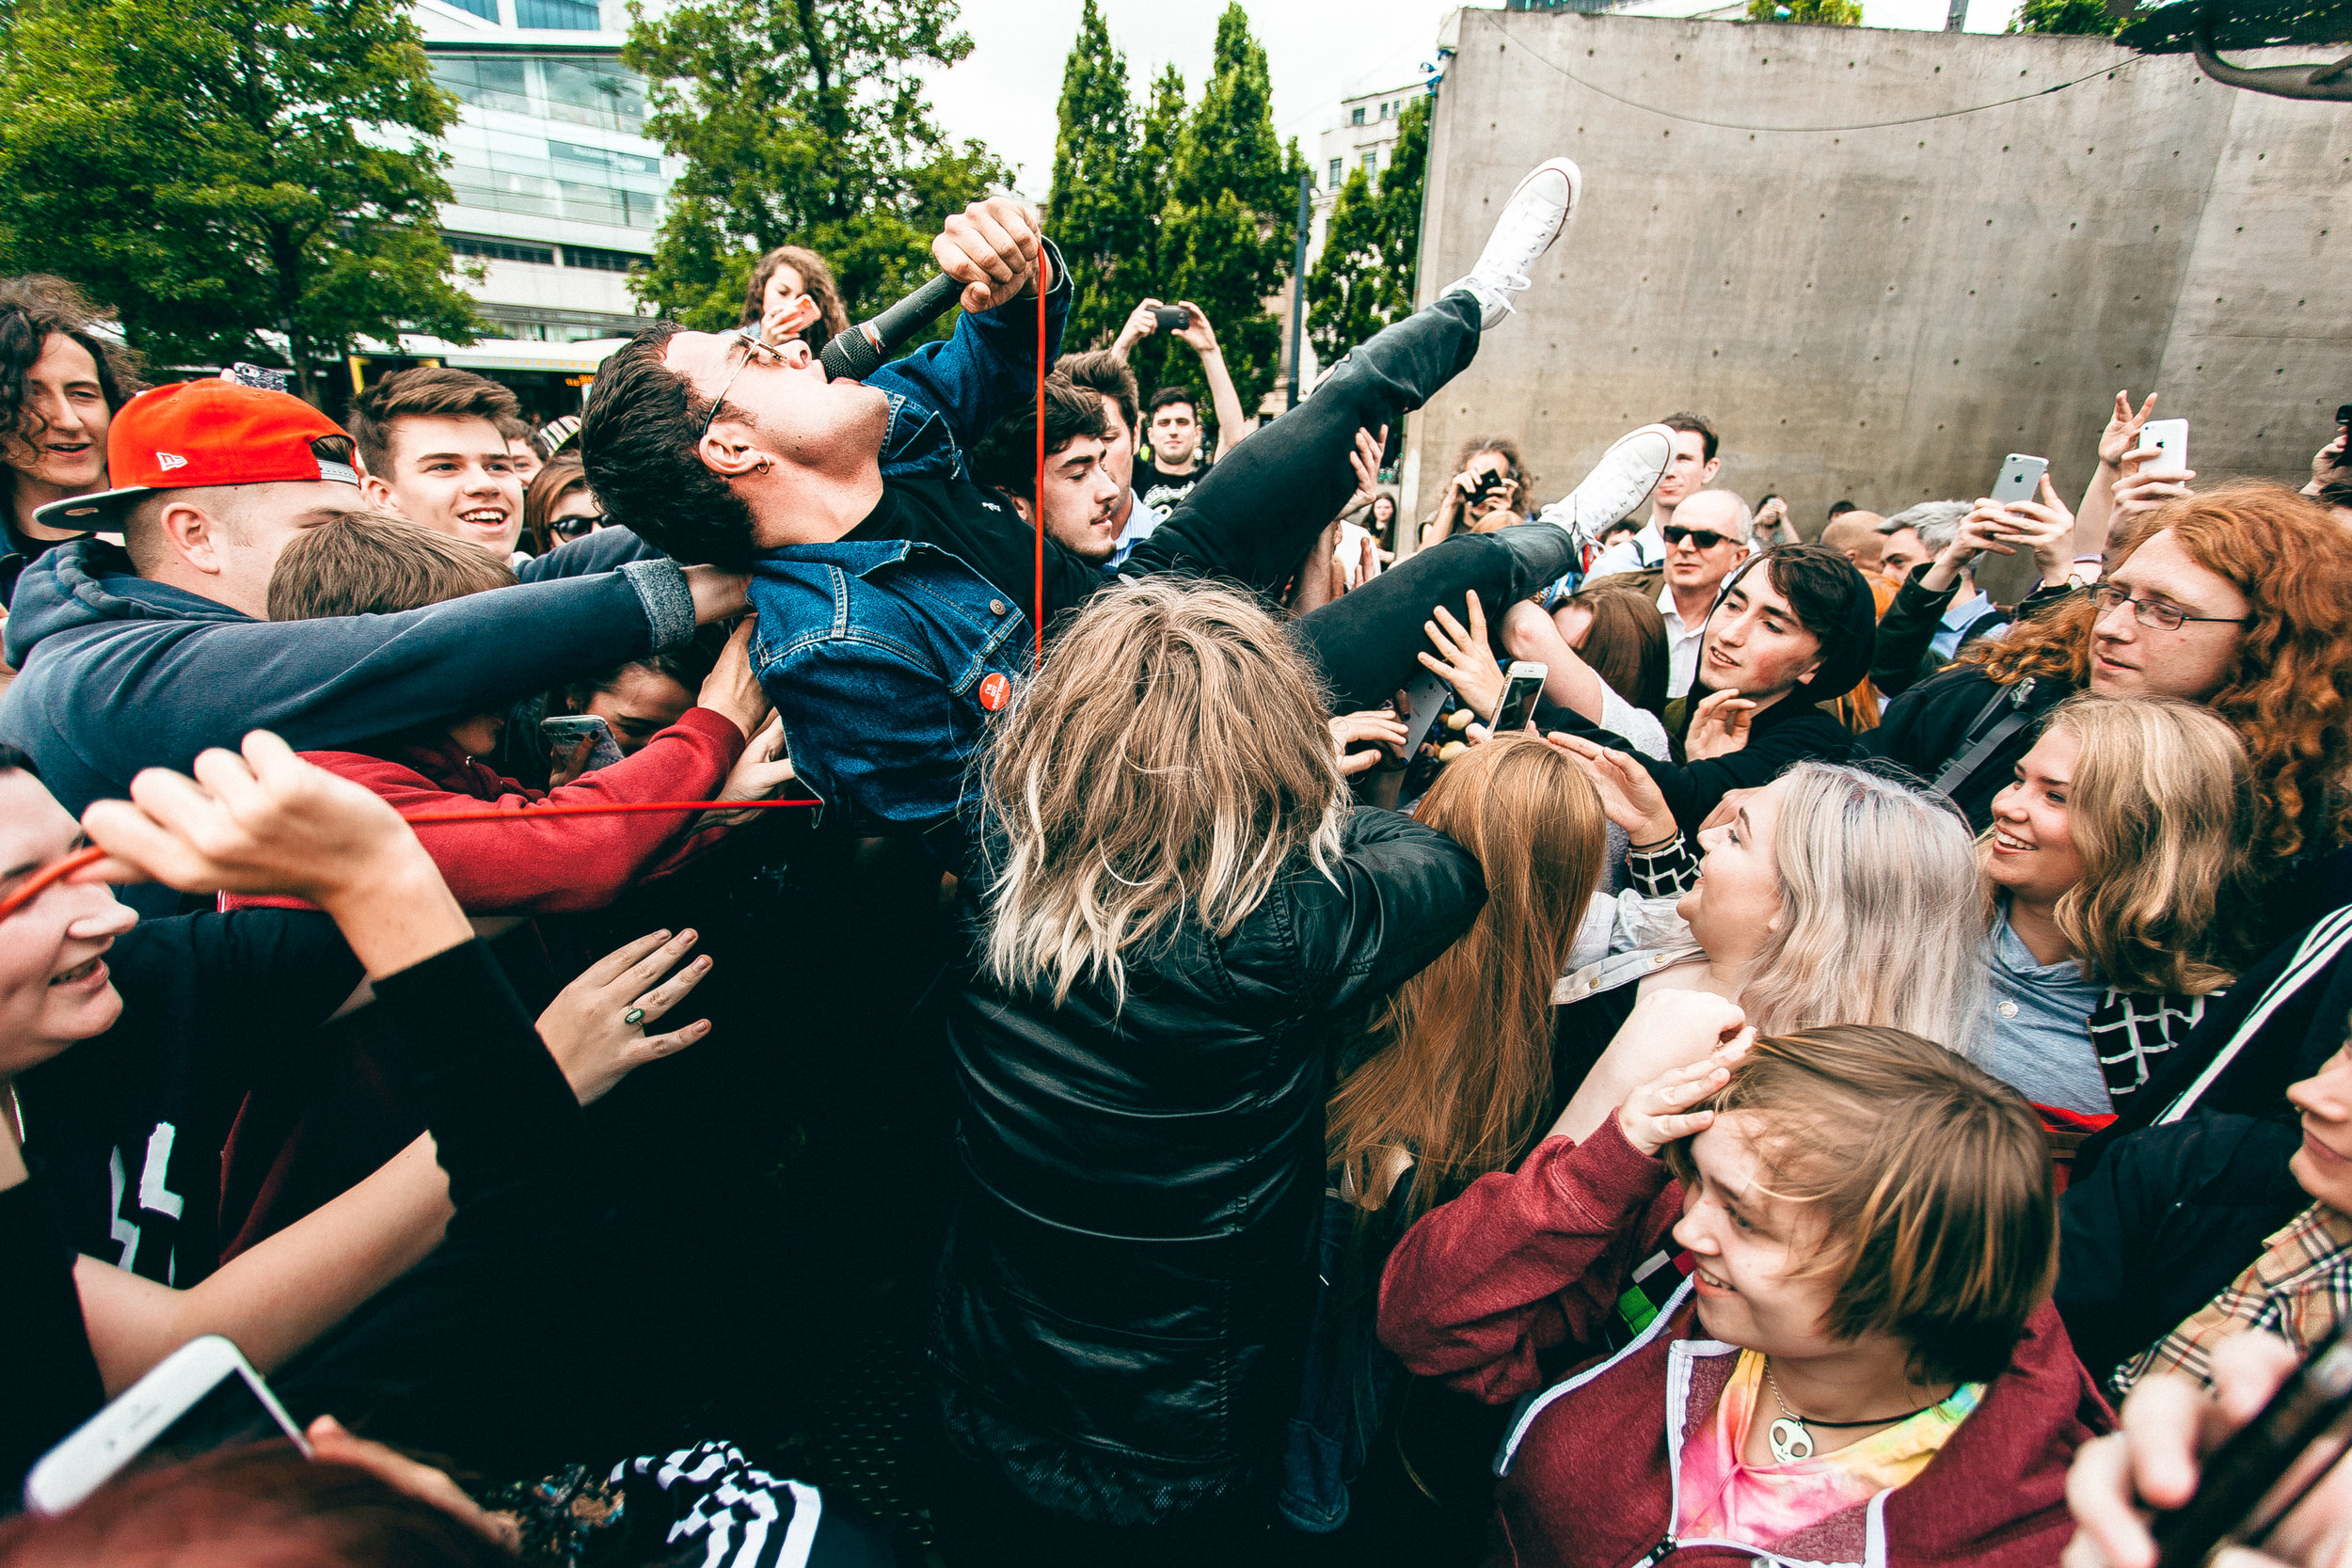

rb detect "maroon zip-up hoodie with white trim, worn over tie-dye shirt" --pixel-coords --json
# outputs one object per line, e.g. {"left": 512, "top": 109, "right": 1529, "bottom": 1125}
{"left": 1381, "top": 1117, "right": 2115, "bottom": 1568}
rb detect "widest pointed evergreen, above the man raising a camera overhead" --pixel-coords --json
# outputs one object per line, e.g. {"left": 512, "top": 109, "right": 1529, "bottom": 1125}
{"left": 1129, "top": 0, "right": 1306, "bottom": 409}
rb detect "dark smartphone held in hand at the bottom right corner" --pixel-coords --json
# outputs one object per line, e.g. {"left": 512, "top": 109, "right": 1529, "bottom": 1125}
{"left": 2150, "top": 1328, "right": 2352, "bottom": 1568}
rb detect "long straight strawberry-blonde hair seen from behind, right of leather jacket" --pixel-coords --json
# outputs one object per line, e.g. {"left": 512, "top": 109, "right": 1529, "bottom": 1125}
{"left": 1325, "top": 736, "right": 1609, "bottom": 1223}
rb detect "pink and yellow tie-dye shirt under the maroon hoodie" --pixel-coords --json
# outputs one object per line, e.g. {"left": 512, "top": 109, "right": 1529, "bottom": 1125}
{"left": 1675, "top": 1350, "right": 1985, "bottom": 1547}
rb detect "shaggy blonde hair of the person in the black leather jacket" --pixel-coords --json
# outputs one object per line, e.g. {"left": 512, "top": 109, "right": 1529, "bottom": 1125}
{"left": 978, "top": 578, "right": 1348, "bottom": 1006}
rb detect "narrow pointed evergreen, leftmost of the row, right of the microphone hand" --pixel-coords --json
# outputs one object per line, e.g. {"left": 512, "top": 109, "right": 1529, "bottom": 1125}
{"left": 1044, "top": 0, "right": 1151, "bottom": 355}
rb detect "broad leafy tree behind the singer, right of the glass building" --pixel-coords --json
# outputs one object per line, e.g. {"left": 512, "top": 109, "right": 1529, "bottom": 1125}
{"left": 621, "top": 0, "right": 1011, "bottom": 326}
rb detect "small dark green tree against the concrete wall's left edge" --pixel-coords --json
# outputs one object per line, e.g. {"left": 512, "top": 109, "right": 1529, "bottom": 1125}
{"left": 1308, "top": 99, "right": 1430, "bottom": 364}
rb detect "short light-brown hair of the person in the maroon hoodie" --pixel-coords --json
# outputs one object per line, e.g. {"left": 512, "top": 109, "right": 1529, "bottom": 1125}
{"left": 1663, "top": 1025, "right": 2058, "bottom": 1383}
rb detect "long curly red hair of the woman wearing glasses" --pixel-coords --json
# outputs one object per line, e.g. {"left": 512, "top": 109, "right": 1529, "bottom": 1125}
{"left": 1966, "top": 482, "right": 2352, "bottom": 870}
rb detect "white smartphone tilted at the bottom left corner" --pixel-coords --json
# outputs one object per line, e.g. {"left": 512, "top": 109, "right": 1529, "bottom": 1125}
{"left": 24, "top": 1333, "right": 310, "bottom": 1514}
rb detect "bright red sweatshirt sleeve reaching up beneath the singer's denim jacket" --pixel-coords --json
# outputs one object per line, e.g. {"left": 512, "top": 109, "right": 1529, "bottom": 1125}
{"left": 221, "top": 707, "right": 743, "bottom": 914}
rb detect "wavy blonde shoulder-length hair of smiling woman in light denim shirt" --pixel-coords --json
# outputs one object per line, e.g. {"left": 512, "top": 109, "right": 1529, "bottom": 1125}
{"left": 1980, "top": 696, "right": 2253, "bottom": 997}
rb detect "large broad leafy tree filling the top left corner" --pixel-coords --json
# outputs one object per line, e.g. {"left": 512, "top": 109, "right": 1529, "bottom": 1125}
{"left": 0, "top": 0, "right": 478, "bottom": 397}
